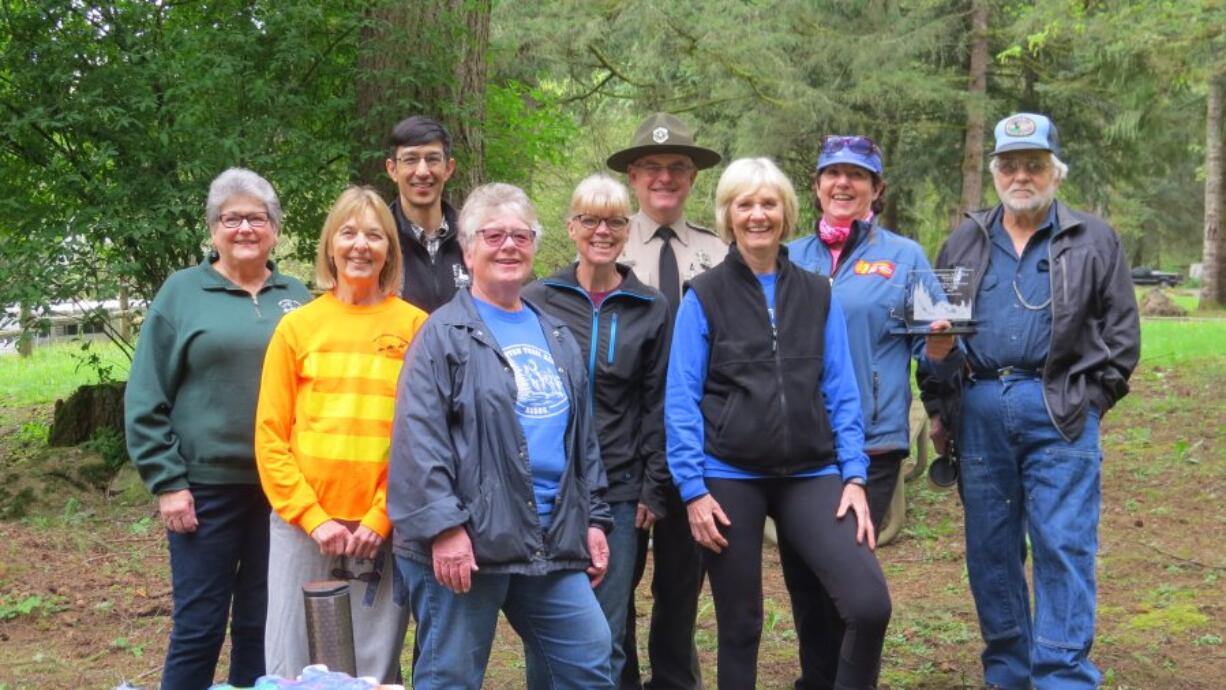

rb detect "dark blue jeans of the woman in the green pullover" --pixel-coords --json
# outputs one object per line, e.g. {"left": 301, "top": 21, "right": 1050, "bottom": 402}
{"left": 162, "top": 484, "right": 268, "bottom": 690}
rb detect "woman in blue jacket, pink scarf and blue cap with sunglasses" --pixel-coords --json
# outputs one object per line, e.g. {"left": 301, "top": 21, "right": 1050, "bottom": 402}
{"left": 780, "top": 135, "right": 960, "bottom": 690}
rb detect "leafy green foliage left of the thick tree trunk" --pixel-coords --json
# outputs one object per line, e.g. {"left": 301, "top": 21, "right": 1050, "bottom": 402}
{"left": 0, "top": 0, "right": 362, "bottom": 330}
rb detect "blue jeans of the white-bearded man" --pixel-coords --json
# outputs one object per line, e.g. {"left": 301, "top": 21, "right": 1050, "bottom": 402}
{"left": 960, "top": 376, "right": 1102, "bottom": 690}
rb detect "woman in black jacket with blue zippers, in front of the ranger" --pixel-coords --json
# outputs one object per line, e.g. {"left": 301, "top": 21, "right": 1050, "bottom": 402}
{"left": 524, "top": 174, "right": 671, "bottom": 683}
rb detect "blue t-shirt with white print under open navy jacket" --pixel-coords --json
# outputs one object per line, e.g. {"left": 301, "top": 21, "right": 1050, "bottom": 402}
{"left": 473, "top": 298, "right": 570, "bottom": 528}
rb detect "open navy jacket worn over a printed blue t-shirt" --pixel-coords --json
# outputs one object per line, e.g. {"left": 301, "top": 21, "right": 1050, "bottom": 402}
{"left": 387, "top": 289, "right": 613, "bottom": 575}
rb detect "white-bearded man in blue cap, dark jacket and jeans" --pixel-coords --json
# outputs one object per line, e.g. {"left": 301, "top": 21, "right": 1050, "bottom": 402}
{"left": 923, "top": 113, "right": 1140, "bottom": 690}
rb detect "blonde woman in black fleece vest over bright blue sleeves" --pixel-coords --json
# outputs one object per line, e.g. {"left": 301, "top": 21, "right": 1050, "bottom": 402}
{"left": 664, "top": 158, "right": 890, "bottom": 690}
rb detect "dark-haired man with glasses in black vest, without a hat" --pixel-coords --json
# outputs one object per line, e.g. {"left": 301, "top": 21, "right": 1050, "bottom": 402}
{"left": 384, "top": 115, "right": 468, "bottom": 314}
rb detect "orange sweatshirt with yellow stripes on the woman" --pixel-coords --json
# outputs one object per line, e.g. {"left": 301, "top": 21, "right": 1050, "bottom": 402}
{"left": 255, "top": 293, "right": 427, "bottom": 538}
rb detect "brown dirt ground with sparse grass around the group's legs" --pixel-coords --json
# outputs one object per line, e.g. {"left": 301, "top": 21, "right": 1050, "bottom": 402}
{"left": 0, "top": 359, "right": 1226, "bottom": 690}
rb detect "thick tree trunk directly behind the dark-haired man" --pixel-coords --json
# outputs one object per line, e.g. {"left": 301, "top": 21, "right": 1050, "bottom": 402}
{"left": 351, "top": 0, "right": 492, "bottom": 205}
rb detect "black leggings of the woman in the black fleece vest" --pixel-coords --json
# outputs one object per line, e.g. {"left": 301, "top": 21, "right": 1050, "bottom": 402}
{"left": 702, "top": 476, "right": 890, "bottom": 690}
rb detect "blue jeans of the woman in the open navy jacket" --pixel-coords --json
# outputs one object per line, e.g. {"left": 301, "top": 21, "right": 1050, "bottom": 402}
{"left": 396, "top": 556, "right": 613, "bottom": 690}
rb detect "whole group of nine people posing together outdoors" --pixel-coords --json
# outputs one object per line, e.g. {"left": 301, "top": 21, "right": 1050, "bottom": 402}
{"left": 125, "top": 113, "right": 1139, "bottom": 690}
